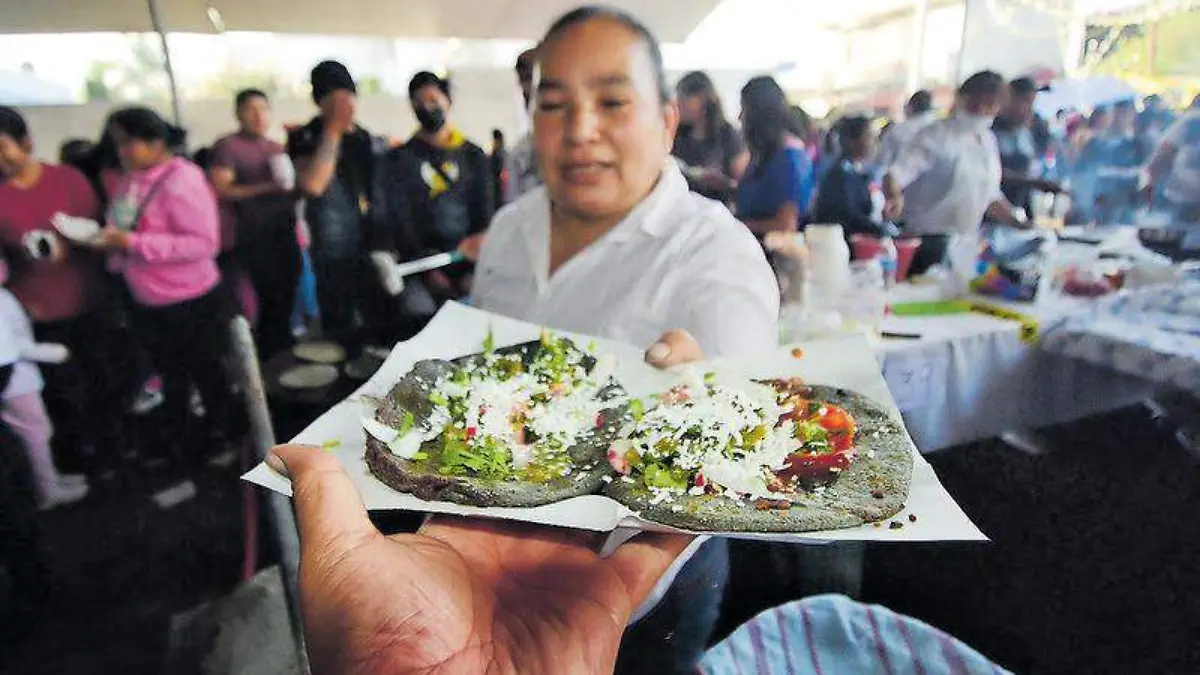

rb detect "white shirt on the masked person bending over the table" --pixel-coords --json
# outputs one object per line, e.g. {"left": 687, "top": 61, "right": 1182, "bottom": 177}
{"left": 888, "top": 115, "right": 1004, "bottom": 234}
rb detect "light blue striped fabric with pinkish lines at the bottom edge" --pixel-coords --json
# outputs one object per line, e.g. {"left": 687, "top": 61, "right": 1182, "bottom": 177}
{"left": 696, "top": 595, "right": 1008, "bottom": 675}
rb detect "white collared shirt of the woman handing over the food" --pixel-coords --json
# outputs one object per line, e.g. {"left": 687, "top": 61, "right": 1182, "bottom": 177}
{"left": 472, "top": 161, "right": 779, "bottom": 621}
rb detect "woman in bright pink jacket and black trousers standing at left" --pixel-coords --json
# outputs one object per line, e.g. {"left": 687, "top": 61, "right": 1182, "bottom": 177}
{"left": 92, "top": 108, "right": 232, "bottom": 459}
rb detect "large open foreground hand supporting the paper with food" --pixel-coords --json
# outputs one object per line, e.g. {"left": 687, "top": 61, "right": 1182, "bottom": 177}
{"left": 268, "top": 446, "right": 691, "bottom": 675}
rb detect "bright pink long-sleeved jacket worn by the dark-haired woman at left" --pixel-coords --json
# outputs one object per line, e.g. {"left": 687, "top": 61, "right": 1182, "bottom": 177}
{"left": 108, "top": 157, "right": 221, "bottom": 307}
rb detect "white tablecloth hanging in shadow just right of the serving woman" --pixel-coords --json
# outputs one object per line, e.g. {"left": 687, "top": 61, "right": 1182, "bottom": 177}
{"left": 881, "top": 281, "right": 1153, "bottom": 453}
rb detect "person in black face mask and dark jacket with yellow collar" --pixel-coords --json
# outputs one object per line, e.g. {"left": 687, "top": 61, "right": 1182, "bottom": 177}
{"left": 372, "top": 72, "right": 493, "bottom": 336}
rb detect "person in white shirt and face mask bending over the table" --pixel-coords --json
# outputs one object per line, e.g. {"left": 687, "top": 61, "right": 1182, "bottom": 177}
{"left": 883, "top": 71, "right": 1024, "bottom": 274}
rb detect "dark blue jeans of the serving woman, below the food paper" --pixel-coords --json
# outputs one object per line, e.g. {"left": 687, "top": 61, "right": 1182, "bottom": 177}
{"left": 616, "top": 537, "right": 730, "bottom": 675}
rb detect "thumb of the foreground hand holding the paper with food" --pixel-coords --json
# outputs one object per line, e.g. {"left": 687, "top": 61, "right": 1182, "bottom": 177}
{"left": 266, "top": 446, "right": 379, "bottom": 561}
